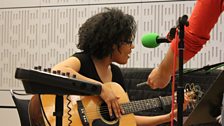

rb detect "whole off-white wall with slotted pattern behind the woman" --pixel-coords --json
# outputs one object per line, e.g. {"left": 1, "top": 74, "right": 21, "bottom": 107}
{"left": 0, "top": 0, "right": 224, "bottom": 125}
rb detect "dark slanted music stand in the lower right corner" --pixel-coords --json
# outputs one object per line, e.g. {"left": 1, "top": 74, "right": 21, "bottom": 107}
{"left": 184, "top": 71, "right": 224, "bottom": 126}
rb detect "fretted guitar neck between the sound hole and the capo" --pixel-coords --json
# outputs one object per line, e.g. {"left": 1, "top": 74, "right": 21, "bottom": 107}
{"left": 121, "top": 96, "right": 172, "bottom": 114}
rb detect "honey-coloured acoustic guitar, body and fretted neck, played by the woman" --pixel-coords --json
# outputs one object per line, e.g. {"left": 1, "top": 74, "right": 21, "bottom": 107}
{"left": 41, "top": 82, "right": 194, "bottom": 126}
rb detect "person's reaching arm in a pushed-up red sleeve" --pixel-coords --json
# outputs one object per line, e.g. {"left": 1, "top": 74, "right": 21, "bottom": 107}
{"left": 147, "top": 0, "right": 224, "bottom": 89}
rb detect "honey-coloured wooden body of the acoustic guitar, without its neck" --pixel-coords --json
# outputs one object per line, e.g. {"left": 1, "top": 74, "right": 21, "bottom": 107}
{"left": 41, "top": 82, "right": 136, "bottom": 126}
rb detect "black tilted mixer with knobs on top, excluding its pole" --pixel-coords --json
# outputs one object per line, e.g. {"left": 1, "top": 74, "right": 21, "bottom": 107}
{"left": 15, "top": 66, "right": 102, "bottom": 95}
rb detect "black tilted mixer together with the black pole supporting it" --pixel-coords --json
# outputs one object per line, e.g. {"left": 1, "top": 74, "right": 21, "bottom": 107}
{"left": 15, "top": 68, "right": 102, "bottom": 126}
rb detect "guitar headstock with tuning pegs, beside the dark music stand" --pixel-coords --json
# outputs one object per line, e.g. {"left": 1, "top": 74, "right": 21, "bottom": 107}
{"left": 184, "top": 83, "right": 204, "bottom": 109}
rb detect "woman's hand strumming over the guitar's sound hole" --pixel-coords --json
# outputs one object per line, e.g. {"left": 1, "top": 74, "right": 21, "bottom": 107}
{"left": 100, "top": 84, "right": 122, "bottom": 118}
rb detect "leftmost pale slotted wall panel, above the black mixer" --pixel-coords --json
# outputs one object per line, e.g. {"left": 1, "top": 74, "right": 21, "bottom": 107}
{"left": 0, "top": 9, "right": 39, "bottom": 88}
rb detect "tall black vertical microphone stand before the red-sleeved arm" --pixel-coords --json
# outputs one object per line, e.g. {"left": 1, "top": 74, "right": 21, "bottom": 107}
{"left": 177, "top": 15, "right": 189, "bottom": 126}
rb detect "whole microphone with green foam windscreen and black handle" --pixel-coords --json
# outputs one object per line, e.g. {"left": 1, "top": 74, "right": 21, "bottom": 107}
{"left": 141, "top": 33, "right": 170, "bottom": 48}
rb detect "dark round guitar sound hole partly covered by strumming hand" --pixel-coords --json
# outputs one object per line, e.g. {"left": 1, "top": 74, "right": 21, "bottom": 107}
{"left": 100, "top": 103, "right": 117, "bottom": 121}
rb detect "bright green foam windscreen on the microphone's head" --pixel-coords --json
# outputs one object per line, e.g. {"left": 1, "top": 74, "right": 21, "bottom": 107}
{"left": 141, "top": 33, "right": 159, "bottom": 48}
